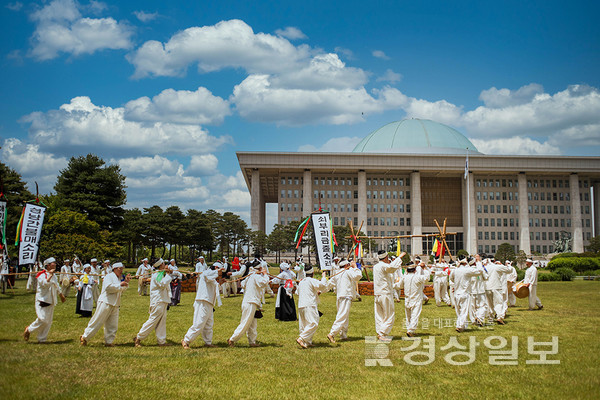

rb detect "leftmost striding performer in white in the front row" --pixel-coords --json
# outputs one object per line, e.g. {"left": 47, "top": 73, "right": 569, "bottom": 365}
{"left": 23, "top": 257, "right": 65, "bottom": 343}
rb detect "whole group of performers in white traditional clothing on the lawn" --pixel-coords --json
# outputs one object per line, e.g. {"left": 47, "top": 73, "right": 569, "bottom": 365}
{"left": 23, "top": 251, "right": 543, "bottom": 349}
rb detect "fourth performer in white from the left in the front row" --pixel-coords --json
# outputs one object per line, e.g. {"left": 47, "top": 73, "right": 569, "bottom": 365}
{"left": 181, "top": 262, "right": 224, "bottom": 349}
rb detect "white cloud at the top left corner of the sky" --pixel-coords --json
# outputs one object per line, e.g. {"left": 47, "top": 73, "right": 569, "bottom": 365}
{"left": 30, "top": 0, "right": 133, "bottom": 60}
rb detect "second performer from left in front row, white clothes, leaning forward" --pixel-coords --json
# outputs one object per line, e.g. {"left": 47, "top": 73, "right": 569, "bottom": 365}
{"left": 79, "top": 262, "right": 130, "bottom": 347}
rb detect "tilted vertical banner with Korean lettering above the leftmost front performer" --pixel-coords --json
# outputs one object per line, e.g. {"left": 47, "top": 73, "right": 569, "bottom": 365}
{"left": 19, "top": 203, "right": 46, "bottom": 265}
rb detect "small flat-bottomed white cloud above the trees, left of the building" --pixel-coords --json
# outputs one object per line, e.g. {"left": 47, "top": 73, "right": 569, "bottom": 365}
{"left": 125, "top": 87, "right": 231, "bottom": 125}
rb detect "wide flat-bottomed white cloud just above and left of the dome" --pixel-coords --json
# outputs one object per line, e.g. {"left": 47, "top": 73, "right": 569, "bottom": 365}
{"left": 231, "top": 75, "right": 406, "bottom": 125}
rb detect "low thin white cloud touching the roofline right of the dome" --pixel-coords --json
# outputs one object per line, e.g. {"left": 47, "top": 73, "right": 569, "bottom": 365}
{"left": 471, "top": 136, "right": 560, "bottom": 155}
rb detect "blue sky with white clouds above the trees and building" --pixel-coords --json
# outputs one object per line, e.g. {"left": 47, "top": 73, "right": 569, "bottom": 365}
{"left": 0, "top": 0, "right": 600, "bottom": 228}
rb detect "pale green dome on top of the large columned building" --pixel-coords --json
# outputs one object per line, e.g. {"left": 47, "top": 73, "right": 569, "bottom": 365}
{"left": 352, "top": 118, "right": 481, "bottom": 154}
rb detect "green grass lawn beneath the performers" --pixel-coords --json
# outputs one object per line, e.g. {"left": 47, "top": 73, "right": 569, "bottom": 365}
{"left": 0, "top": 281, "right": 600, "bottom": 399}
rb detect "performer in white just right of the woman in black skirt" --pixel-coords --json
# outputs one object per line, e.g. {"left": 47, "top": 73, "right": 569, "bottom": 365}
{"left": 296, "top": 267, "right": 328, "bottom": 349}
